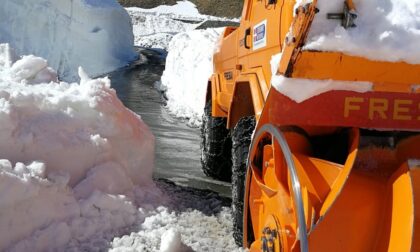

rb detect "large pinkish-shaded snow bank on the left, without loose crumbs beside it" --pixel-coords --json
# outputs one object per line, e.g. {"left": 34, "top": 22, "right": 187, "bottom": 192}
{"left": 0, "top": 44, "right": 154, "bottom": 251}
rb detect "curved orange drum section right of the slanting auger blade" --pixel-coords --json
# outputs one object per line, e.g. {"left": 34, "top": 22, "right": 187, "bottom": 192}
{"left": 309, "top": 165, "right": 414, "bottom": 251}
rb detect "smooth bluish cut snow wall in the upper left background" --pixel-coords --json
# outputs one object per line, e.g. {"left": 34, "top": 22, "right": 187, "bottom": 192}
{"left": 0, "top": 0, "right": 137, "bottom": 81}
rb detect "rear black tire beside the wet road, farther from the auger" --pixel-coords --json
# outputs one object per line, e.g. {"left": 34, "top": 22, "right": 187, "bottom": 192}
{"left": 201, "top": 101, "right": 232, "bottom": 182}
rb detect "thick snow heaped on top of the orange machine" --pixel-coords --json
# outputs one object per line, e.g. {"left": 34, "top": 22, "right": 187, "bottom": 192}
{"left": 301, "top": 0, "right": 420, "bottom": 64}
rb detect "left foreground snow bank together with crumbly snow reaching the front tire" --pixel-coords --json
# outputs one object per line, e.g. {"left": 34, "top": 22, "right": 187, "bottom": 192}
{"left": 0, "top": 44, "right": 241, "bottom": 252}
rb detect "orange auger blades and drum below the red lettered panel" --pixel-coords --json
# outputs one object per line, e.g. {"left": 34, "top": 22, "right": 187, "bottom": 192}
{"left": 244, "top": 130, "right": 420, "bottom": 251}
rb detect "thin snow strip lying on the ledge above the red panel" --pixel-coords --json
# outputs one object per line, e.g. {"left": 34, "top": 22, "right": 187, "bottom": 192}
{"left": 271, "top": 53, "right": 373, "bottom": 103}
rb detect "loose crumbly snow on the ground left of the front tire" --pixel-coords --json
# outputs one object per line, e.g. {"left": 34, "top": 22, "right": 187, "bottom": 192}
{"left": 112, "top": 182, "right": 244, "bottom": 252}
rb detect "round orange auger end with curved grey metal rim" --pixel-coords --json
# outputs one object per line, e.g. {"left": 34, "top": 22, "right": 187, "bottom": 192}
{"left": 244, "top": 124, "right": 308, "bottom": 252}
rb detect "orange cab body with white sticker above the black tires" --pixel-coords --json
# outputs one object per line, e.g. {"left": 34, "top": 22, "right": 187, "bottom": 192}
{"left": 212, "top": 0, "right": 295, "bottom": 123}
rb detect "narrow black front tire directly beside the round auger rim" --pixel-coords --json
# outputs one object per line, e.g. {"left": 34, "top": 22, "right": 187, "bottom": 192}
{"left": 232, "top": 116, "right": 255, "bottom": 246}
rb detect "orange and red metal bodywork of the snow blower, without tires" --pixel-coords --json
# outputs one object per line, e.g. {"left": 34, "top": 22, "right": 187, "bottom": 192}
{"left": 211, "top": 0, "right": 420, "bottom": 252}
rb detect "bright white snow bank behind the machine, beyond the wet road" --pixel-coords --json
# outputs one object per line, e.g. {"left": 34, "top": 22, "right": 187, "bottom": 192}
{"left": 162, "top": 28, "right": 223, "bottom": 125}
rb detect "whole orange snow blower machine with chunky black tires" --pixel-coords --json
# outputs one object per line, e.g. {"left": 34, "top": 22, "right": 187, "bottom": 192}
{"left": 202, "top": 0, "right": 420, "bottom": 251}
